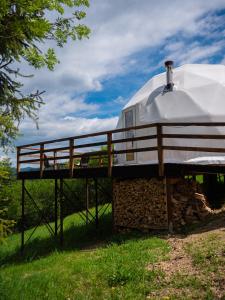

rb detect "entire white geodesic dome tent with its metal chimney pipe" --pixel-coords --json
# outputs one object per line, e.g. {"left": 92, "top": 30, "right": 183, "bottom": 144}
{"left": 115, "top": 61, "right": 225, "bottom": 165}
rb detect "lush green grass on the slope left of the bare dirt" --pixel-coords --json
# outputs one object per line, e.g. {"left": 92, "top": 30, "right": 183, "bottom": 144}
{"left": 0, "top": 206, "right": 169, "bottom": 300}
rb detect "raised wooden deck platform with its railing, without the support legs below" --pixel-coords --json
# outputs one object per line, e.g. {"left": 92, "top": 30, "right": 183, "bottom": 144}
{"left": 17, "top": 123, "right": 225, "bottom": 179}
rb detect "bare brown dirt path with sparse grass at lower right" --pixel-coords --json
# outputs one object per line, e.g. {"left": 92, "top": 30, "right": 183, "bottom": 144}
{"left": 147, "top": 212, "right": 225, "bottom": 299}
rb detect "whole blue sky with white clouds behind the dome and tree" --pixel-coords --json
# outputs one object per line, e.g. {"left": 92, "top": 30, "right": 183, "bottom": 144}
{"left": 7, "top": 0, "right": 225, "bottom": 150}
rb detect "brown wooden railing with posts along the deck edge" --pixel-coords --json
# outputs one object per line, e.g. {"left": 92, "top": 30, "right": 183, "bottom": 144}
{"left": 17, "top": 122, "right": 225, "bottom": 178}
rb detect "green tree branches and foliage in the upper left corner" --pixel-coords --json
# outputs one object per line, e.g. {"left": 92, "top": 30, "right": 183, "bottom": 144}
{"left": 0, "top": 0, "right": 90, "bottom": 146}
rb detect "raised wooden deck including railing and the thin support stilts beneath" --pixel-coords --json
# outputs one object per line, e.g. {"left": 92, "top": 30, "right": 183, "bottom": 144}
{"left": 17, "top": 123, "right": 225, "bottom": 252}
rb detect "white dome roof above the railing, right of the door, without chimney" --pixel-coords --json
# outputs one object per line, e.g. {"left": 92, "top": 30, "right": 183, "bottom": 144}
{"left": 123, "top": 64, "right": 225, "bottom": 123}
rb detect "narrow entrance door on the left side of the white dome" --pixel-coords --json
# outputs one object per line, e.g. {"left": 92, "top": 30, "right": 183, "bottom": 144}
{"left": 124, "top": 107, "right": 136, "bottom": 161}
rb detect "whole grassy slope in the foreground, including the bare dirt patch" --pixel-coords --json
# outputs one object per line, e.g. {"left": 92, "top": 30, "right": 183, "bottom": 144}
{"left": 0, "top": 207, "right": 225, "bottom": 300}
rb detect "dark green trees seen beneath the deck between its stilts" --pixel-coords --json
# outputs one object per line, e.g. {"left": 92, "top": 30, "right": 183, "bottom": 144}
{"left": 0, "top": 160, "right": 111, "bottom": 237}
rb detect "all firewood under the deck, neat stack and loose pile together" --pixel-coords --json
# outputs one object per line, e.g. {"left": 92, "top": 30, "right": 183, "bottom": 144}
{"left": 113, "top": 178, "right": 212, "bottom": 230}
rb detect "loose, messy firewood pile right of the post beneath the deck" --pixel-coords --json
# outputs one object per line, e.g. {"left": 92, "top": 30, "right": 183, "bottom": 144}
{"left": 171, "top": 179, "right": 212, "bottom": 228}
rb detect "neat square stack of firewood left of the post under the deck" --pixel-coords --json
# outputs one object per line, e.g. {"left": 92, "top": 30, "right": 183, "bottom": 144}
{"left": 113, "top": 178, "right": 168, "bottom": 229}
